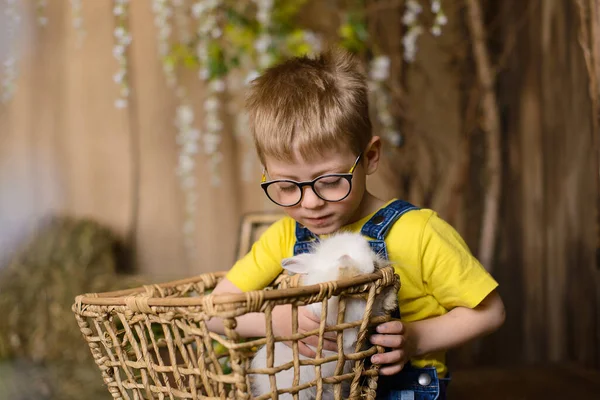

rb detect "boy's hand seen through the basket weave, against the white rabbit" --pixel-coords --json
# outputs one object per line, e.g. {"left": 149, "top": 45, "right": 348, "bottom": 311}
{"left": 273, "top": 305, "right": 337, "bottom": 358}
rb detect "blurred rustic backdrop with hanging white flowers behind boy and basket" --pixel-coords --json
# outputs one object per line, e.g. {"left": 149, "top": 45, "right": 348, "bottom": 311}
{"left": 0, "top": 0, "right": 600, "bottom": 399}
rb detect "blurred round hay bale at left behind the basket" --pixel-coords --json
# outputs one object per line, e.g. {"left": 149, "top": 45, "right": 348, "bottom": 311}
{"left": 0, "top": 218, "right": 145, "bottom": 399}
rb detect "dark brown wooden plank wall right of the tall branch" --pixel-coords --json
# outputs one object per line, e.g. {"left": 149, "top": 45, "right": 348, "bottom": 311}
{"left": 461, "top": 0, "right": 600, "bottom": 367}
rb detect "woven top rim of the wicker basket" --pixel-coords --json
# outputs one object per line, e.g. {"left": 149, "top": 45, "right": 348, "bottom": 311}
{"left": 76, "top": 266, "right": 397, "bottom": 307}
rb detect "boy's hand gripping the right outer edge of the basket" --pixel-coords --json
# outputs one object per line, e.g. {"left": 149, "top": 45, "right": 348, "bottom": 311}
{"left": 370, "top": 321, "right": 415, "bottom": 375}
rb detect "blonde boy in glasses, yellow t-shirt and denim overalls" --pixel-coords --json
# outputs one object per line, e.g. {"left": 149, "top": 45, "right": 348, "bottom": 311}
{"left": 210, "top": 51, "right": 504, "bottom": 399}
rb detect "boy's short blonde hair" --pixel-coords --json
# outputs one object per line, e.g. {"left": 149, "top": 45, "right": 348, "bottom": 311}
{"left": 246, "top": 50, "right": 372, "bottom": 165}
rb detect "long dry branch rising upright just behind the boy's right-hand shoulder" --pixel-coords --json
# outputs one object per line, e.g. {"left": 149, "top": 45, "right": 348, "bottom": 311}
{"left": 466, "top": 0, "right": 501, "bottom": 271}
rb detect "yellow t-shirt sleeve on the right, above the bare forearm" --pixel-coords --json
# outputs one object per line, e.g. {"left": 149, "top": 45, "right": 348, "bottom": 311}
{"left": 421, "top": 213, "right": 498, "bottom": 310}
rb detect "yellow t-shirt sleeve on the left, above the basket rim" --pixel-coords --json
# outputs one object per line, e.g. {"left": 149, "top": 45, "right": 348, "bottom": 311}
{"left": 226, "top": 217, "right": 295, "bottom": 292}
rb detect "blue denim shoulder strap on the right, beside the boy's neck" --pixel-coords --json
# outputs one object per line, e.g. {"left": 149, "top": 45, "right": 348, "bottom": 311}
{"left": 360, "top": 200, "right": 419, "bottom": 260}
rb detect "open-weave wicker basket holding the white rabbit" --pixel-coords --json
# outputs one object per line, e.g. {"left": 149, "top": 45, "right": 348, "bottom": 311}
{"left": 73, "top": 267, "right": 399, "bottom": 399}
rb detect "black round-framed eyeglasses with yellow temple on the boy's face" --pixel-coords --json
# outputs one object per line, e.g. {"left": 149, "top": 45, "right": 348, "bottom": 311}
{"left": 260, "top": 153, "right": 363, "bottom": 207}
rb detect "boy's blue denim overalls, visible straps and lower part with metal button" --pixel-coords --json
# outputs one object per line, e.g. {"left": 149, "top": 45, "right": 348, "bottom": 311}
{"left": 294, "top": 200, "right": 448, "bottom": 400}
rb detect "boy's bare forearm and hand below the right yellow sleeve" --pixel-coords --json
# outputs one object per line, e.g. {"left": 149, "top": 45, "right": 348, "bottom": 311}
{"left": 371, "top": 291, "right": 505, "bottom": 375}
